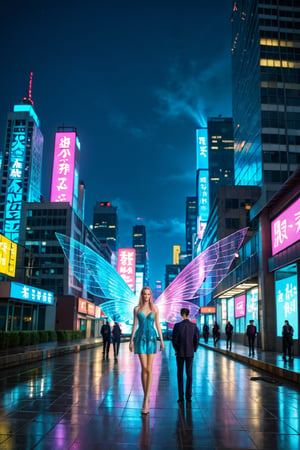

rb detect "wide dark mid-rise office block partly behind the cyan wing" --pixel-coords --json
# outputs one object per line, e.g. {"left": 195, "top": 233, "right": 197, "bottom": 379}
{"left": 17, "top": 202, "right": 111, "bottom": 299}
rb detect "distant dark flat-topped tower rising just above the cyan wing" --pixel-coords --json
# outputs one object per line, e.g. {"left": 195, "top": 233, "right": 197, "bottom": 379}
{"left": 93, "top": 202, "right": 118, "bottom": 253}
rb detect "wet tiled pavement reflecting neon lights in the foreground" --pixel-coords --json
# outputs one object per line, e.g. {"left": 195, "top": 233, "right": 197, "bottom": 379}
{"left": 0, "top": 342, "right": 300, "bottom": 450}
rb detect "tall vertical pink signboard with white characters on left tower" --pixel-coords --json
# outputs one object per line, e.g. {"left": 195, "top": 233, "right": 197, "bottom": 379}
{"left": 51, "top": 132, "right": 76, "bottom": 205}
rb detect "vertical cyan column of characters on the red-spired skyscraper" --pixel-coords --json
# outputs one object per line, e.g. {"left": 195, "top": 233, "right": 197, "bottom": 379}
{"left": 4, "top": 127, "right": 26, "bottom": 242}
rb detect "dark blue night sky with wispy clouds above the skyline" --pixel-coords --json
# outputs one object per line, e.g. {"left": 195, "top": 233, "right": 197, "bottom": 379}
{"left": 0, "top": 0, "right": 232, "bottom": 287}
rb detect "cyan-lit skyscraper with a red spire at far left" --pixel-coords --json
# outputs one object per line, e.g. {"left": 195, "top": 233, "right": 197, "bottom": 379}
{"left": 0, "top": 73, "right": 44, "bottom": 242}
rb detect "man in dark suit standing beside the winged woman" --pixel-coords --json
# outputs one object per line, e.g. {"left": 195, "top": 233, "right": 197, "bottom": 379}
{"left": 172, "top": 308, "right": 200, "bottom": 402}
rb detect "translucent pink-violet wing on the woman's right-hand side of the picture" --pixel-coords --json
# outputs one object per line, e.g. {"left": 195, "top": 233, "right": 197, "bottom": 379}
{"left": 155, "top": 228, "right": 248, "bottom": 323}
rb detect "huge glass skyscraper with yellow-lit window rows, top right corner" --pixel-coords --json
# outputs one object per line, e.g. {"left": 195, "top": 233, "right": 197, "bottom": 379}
{"left": 232, "top": 0, "right": 300, "bottom": 202}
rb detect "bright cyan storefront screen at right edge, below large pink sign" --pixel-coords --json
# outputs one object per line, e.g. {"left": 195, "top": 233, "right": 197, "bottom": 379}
{"left": 275, "top": 264, "right": 298, "bottom": 339}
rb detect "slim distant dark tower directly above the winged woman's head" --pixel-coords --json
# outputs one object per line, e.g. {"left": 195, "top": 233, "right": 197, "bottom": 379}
{"left": 132, "top": 225, "right": 149, "bottom": 286}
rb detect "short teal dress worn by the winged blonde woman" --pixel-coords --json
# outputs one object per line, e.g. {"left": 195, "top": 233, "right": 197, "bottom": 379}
{"left": 133, "top": 311, "right": 157, "bottom": 354}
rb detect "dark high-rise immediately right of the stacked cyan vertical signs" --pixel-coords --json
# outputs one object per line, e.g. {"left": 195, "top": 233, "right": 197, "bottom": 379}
{"left": 207, "top": 117, "right": 234, "bottom": 209}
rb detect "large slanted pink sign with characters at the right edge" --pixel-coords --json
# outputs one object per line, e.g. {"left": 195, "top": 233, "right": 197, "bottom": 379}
{"left": 271, "top": 198, "right": 300, "bottom": 255}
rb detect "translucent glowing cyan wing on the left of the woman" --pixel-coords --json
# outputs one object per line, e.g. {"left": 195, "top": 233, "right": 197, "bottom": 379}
{"left": 55, "top": 233, "right": 137, "bottom": 322}
